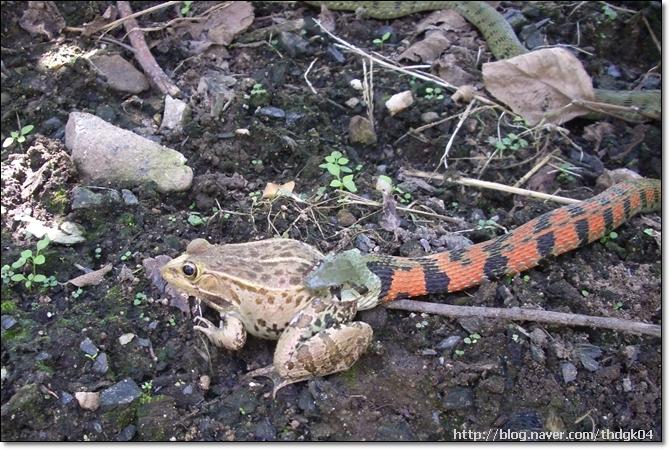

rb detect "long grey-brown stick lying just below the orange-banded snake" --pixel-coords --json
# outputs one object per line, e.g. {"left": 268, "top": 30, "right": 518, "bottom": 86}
{"left": 384, "top": 300, "right": 661, "bottom": 337}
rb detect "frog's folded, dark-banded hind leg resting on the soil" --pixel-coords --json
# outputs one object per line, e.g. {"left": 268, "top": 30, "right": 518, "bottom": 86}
{"left": 247, "top": 298, "right": 372, "bottom": 397}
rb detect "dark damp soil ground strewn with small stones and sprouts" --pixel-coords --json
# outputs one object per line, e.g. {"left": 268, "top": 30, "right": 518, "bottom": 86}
{"left": 1, "top": 2, "right": 662, "bottom": 441}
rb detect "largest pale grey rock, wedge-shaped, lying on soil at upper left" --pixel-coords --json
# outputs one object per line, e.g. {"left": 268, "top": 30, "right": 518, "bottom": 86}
{"left": 65, "top": 112, "right": 193, "bottom": 192}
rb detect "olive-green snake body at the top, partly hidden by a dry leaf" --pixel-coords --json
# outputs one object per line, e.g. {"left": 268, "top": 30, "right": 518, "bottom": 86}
{"left": 306, "top": 1, "right": 661, "bottom": 122}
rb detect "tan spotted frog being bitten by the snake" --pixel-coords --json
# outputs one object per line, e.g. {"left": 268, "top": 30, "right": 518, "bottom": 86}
{"left": 161, "top": 238, "right": 372, "bottom": 397}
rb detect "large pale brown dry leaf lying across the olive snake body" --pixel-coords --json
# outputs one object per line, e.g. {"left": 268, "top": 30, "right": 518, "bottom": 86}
{"left": 483, "top": 48, "right": 594, "bottom": 126}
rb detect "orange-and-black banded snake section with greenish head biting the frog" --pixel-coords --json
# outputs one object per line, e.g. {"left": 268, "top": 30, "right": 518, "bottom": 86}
{"left": 305, "top": 178, "right": 661, "bottom": 310}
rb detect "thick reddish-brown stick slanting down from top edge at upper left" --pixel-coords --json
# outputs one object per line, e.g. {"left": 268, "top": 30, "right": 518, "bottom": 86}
{"left": 116, "top": 1, "right": 180, "bottom": 97}
